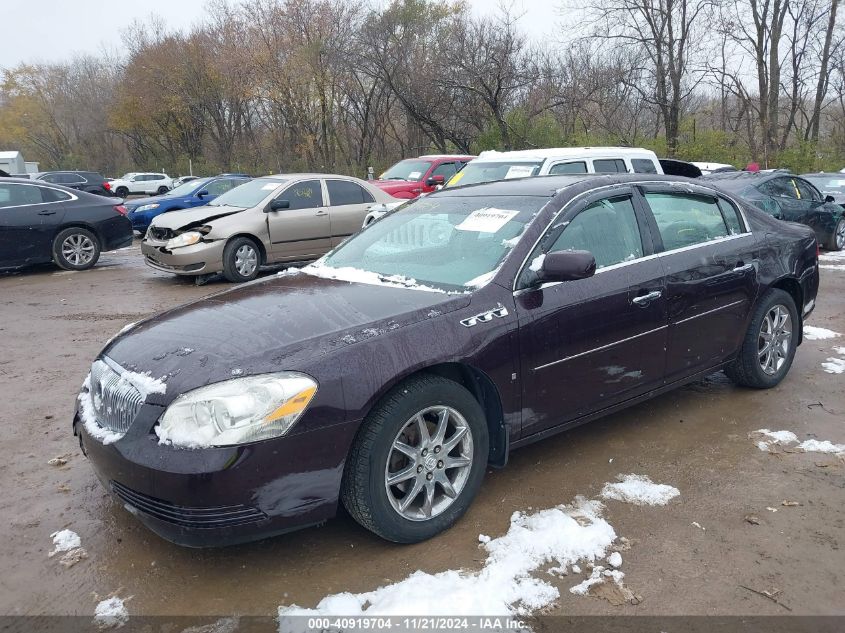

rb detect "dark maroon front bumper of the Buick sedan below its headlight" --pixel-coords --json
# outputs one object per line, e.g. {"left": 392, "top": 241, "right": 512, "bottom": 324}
{"left": 74, "top": 404, "right": 358, "bottom": 547}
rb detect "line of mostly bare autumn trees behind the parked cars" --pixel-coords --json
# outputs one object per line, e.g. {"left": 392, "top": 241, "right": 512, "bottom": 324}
{"left": 0, "top": 0, "right": 845, "bottom": 176}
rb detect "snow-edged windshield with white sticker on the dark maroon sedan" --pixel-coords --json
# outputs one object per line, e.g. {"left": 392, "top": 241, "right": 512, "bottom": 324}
{"left": 317, "top": 196, "right": 549, "bottom": 292}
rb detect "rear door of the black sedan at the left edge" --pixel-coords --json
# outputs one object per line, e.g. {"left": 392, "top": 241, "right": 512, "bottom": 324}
{"left": 0, "top": 181, "right": 71, "bottom": 266}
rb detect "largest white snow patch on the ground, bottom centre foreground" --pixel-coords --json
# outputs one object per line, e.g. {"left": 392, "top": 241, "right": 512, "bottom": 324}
{"left": 278, "top": 497, "right": 621, "bottom": 616}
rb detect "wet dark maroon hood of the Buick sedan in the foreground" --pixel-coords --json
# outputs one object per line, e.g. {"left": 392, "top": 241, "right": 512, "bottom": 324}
{"left": 102, "top": 273, "right": 470, "bottom": 405}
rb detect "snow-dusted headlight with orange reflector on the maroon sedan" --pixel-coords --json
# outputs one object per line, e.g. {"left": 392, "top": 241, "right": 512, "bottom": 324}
{"left": 155, "top": 371, "right": 317, "bottom": 448}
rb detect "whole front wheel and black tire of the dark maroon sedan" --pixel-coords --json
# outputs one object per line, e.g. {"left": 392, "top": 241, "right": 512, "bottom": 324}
{"left": 341, "top": 375, "right": 489, "bottom": 543}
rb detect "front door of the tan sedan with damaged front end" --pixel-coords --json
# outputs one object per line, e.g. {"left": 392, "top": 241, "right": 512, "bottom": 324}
{"left": 267, "top": 179, "right": 332, "bottom": 261}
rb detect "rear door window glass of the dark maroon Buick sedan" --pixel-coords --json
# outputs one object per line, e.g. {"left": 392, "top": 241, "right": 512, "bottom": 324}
{"left": 645, "top": 193, "right": 728, "bottom": 251}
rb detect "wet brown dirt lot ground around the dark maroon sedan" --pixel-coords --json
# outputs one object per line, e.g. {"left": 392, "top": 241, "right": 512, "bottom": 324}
{"left": 0, "top": 242, "right": 845, "bottom": 616}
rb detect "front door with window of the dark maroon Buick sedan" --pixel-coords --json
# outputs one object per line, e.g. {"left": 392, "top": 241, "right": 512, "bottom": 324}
{"left": 516, "top": 187, "right": 666, "bottom": 435}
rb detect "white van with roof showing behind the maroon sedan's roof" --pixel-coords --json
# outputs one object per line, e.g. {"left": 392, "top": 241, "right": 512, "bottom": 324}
{"left": 446, "top": 147, "right": 663, "bottom": 187}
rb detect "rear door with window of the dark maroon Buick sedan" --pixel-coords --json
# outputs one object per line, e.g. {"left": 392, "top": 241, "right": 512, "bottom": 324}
{"left": 642, "top": 185, "right": 760, "bottom": 383}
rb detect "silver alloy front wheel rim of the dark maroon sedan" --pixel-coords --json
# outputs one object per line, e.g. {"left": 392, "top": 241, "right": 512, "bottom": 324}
{"left": 384, "top": 405, "right": 473, "bottom": 521}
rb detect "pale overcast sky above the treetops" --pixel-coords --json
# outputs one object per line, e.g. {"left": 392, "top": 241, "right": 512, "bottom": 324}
{"left": 0, "top": 0, "right": 559, "bottom": 68}
